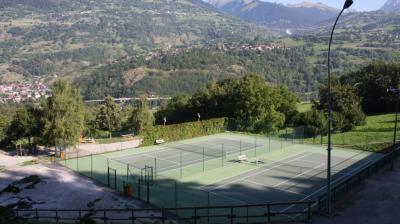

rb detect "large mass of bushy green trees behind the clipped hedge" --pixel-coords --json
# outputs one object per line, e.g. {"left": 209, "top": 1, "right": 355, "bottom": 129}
{"left": 156, "top": 75, "right": 298, "bottom": 131}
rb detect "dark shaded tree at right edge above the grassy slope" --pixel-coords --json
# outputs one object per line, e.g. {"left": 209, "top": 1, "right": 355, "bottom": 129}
{"left": 341, "top": 62, "right": 400, "bottom": 114}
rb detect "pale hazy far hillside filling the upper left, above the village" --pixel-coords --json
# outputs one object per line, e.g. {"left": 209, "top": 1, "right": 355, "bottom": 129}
{"left": 0, "top": 0, "right": 266, "bottom": 82}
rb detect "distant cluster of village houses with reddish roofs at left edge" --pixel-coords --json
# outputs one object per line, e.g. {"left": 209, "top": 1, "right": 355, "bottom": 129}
{"left": 0, "top": 80, "right": 51, "bottom": 103}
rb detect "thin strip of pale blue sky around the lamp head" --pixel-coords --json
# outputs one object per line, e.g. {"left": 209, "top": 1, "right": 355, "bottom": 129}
{"left": 263, "top": 0, "right": 386, "bottom": 11}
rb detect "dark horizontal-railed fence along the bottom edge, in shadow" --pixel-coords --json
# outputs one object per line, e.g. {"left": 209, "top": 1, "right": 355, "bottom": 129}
{"left": 12, "top": 201, "right": 315, "bottom": 224}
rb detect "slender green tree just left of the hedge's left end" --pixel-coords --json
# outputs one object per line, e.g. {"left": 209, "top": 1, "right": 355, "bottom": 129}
{"left": 128, "top": 97, "right": 154, "bottom": 134}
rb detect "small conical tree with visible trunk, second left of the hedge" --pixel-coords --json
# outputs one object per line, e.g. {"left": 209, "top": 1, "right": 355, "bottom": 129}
{"left": 96, "top": 96, "right": 122, "bottom": 138}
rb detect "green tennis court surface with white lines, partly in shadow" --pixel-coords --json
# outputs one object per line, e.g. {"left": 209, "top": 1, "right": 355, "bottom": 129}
{"left": 59, "top": 133, "right": 381, "bottom": 221}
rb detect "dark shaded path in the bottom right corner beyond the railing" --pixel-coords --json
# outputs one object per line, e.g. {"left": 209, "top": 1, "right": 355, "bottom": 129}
{"left": 312, "top": 160, "right": 400, "bottom": 224}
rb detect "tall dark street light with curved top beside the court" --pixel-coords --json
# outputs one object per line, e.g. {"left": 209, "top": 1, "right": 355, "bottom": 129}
{"left": 326, "top": 0, "right": 353, "bottom": 215}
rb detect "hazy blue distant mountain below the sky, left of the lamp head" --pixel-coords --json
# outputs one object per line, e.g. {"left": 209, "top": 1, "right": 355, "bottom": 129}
{"left": 208, "top": 0, "right": 338, "bottom": 31}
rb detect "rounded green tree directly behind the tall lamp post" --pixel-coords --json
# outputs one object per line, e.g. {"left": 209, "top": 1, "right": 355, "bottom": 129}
{"left": 316, "top": 78, "right": 365, "bottom": 132}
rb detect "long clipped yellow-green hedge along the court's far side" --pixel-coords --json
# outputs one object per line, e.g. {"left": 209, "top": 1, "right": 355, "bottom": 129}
{"left": 142, "top": 118, "right": 228, "bottom": 146}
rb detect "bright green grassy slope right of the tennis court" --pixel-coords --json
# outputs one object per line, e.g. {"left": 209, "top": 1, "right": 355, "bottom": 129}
{"left": 306, "top": 114, "right": 400, "bottom": 152}
